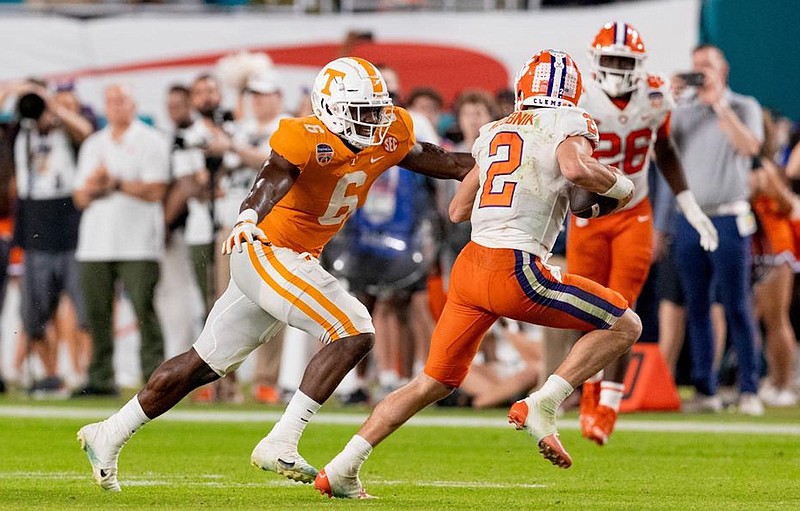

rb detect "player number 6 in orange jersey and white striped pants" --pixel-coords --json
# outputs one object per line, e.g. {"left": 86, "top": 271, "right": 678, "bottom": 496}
{"left": 78, "top": 57, "right": 475, "bottom": 491}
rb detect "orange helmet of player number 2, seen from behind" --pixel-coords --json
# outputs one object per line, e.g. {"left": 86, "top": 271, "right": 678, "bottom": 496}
{"left": 514, "top": 50, "right": 583, "bottom": 110}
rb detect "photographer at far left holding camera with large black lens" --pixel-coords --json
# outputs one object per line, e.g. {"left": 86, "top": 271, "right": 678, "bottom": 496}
{"left": 14, "top": 83, "right": 94, "bottom": 391}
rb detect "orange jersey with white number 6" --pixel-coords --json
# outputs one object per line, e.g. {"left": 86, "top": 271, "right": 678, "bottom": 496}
{"left": 258, "top": 107, "right": 416, "bottom": 257}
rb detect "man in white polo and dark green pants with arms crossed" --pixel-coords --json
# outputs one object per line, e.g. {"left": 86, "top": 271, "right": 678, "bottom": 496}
{"left": 74, "top": 85, "right": 169, "bottom": 395}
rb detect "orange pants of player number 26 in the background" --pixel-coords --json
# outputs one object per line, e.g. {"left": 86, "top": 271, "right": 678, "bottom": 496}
{"left": 567, "top": 197, "right": 653, "bottom": 304}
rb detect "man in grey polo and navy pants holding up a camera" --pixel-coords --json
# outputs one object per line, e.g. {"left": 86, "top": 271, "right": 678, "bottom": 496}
{"left": 672, "top": 45, "right": 764, "bottom": 415}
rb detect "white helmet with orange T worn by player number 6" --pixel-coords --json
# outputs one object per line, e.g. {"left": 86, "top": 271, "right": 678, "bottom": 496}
{"left": 311, "top": 57, "right": 394, "bottom": 149}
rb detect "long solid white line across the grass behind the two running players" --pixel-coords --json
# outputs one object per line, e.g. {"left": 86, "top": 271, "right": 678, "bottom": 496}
{"left": 0, "top": 406, "right": 800, "bottom": 436}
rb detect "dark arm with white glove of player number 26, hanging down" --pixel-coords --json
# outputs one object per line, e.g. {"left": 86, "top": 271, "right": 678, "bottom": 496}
{"left": 653, "top": 136, "right": 719, "bottom": 252}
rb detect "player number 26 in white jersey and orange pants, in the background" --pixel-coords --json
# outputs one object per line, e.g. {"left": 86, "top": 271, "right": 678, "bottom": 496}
{"left": 567, "top": 22, "right": 717, "bottom": 445}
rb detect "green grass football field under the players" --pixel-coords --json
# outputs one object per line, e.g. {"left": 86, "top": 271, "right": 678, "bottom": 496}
{"left": 0, "top": 399, "right": 800, "bottom": 511}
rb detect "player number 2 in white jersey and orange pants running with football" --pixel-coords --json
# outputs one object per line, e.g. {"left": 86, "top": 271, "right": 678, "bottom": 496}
{"left": 314, "top": 50, "right": 641, "bottom": 498}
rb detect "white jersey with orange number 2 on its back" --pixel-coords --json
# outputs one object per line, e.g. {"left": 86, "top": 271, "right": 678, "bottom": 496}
{"left": 471, "top": 108, "right": 597, "bottom": 259}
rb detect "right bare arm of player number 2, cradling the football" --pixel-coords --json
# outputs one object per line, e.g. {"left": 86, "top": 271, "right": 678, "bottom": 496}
{"left": 556, "top": 136, "right": 633, "bottom": 197}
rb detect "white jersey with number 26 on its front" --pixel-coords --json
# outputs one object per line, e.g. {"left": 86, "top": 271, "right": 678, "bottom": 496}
{"left": 580, "top": 75, "right": 674, "bottom": 209}
